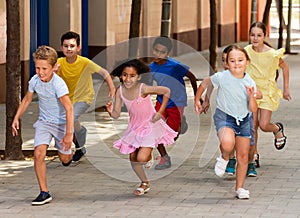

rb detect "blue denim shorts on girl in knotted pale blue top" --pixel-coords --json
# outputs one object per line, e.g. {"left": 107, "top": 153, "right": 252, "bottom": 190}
{"left": 213, "top": 108, "right": 251, "bottom": 138}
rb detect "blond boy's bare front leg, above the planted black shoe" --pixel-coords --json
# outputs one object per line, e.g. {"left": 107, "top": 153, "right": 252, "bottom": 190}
{"left": 34, "top": 145, "right": 49, "bottom": 192}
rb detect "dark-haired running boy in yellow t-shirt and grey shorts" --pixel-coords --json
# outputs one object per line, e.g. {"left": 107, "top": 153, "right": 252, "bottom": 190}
{"left": 57, "top": 31, "right": 115, "bottom": 161}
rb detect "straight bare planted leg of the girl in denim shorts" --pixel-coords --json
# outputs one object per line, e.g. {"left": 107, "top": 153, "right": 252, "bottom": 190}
{"left": 236, "top": 136, "right": 250, "bottom": 190}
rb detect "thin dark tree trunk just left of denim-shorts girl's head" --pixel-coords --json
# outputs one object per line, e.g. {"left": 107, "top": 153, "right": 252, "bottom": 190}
{"left": 209, "top": 0, "right": 218, "bottom": 75}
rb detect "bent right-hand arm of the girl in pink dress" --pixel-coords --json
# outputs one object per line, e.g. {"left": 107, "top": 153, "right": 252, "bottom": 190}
{"left": 142, "top": 85, "right": 171, "bottom": 123}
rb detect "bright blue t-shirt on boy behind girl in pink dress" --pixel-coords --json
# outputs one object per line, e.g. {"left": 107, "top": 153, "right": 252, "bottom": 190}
{"left": 149, "top": 57, "right": 189, "bottom": 108}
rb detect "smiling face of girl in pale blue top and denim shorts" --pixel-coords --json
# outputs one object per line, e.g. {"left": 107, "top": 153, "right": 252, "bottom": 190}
{"left": 228, "top": 50, "right": 249, "bottom": 77}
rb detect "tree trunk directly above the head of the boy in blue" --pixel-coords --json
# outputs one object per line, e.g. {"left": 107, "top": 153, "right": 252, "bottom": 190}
{"left": 160, "top": 0, "right": 172, "bottom": 37}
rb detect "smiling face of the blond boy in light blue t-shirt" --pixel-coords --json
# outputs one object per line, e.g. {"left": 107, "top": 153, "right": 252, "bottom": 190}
{"left": 35, "top": 59, "right": 53, "bottom": 82}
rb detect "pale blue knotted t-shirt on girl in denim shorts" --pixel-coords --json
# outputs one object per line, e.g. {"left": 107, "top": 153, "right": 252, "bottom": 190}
{"left": 210, "top": 70, "right": 256, "bottom": 121}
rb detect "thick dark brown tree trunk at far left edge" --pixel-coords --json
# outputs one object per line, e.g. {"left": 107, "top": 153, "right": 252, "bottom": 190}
{"left": 4, "top": 0, "right": 24, "bottom": 160}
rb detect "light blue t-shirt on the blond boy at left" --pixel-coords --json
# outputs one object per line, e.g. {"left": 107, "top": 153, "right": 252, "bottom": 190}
{"left": 28, "top": 73, "right": 69, "bottom": 124}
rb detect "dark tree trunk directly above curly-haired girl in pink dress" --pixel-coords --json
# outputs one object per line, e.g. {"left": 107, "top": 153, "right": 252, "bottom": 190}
{"left": 128, "top": 0, "right": 142, "bottom": 58}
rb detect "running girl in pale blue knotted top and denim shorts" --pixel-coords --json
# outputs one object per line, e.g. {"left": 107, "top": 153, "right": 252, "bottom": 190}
{"left": 195, "top": 45, "right": 257, "bottom": 199}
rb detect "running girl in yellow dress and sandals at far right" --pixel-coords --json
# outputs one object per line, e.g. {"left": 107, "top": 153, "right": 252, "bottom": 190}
{"left": 245, "top": 22, "right": 291, "bottom": 166}
